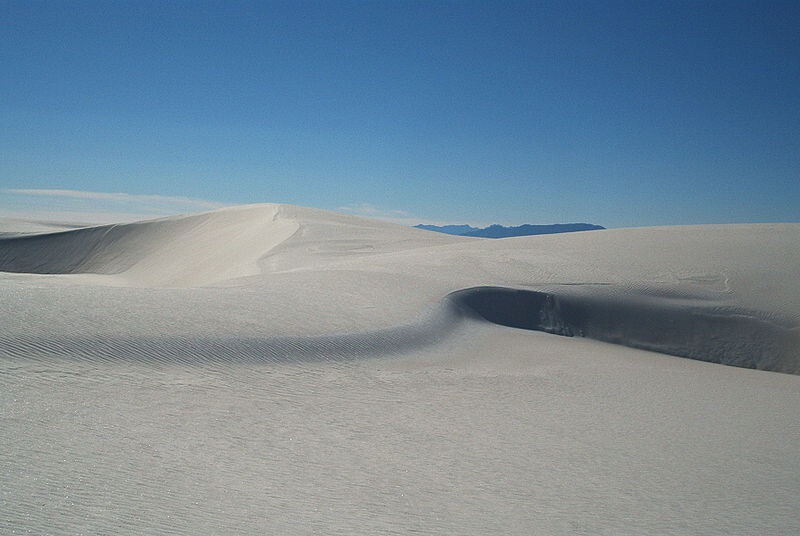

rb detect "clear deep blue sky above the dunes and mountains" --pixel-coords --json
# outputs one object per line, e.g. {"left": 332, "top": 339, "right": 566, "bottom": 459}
{"left": 0, "top": 0, "right": 800, "bottom": 227}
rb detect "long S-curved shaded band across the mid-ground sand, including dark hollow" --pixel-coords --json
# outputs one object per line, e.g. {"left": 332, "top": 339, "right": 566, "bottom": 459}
{"left": 0, "top": 287, "right": 800, "bottom": 374}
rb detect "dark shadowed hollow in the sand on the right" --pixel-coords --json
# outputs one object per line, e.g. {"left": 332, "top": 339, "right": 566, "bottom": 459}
{"left": 450, "top": 287, "right": 800, "bottom": 374}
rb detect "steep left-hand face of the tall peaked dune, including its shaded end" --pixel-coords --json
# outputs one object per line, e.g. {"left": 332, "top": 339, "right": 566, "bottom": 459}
{"left": 0, "top": 204, "right": 300, "bottom": 287}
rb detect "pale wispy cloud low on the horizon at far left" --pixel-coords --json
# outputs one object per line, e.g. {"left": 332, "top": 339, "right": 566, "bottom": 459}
{"left": 0, "top": 188, "right": 225, "bottom": 223}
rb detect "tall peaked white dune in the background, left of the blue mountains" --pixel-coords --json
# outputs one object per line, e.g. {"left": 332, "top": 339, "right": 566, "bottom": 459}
{"left": 0, "top": 204, "right": 468, "bottom": 287}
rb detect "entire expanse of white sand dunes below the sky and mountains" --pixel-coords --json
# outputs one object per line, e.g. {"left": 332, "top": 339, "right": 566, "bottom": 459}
{"left": 0, "top": 205, "right": 800, "bottom": 534}
